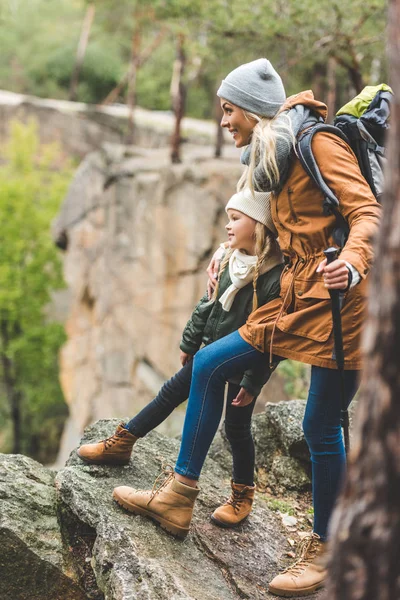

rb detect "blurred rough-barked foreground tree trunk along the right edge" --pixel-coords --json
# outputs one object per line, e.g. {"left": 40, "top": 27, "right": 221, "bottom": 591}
{"left": 327, "top": 0, "right": 400, "bottom": 600}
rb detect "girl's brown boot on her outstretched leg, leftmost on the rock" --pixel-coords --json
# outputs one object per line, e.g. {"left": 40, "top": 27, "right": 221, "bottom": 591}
{"left": 77, "top": 423, "right": 138, "bottom": 465}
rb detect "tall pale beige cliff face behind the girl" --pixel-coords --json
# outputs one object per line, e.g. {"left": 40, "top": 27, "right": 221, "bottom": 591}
{"left": 54, "top": 145, "right": 285, "bottom": 457}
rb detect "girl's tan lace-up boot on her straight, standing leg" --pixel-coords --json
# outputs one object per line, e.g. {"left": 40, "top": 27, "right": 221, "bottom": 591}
{"left": 211, "top": 481, "right": 256, "bottom": 527}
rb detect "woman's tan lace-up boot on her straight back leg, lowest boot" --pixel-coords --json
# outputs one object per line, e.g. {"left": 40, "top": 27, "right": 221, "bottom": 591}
{"left": 268, "top": 533, "right": 327, "bottom": 597}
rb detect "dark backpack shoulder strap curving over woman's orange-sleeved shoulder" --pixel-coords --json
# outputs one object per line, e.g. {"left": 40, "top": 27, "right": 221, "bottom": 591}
{"left": 296, "top": 123, "right": 349, "bottom": 247}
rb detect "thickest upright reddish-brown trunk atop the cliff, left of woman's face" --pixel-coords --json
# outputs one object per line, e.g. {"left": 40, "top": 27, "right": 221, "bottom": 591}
{"left": 171, "top": 34, "right": 186, "bottom": 163}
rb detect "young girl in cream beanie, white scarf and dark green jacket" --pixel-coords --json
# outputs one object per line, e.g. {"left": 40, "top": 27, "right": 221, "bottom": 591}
{"left": 78, "top": 189, "right": 283, "bottom": 527}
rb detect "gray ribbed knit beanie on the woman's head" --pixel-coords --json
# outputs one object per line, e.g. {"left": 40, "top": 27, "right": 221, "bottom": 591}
{"left": 217, "top": 58, "right": 286, "bottom": 117}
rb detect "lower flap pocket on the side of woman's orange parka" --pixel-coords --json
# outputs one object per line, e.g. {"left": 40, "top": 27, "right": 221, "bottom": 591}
{"left": 277, "top": 278, "right": 332, "bottom": 342}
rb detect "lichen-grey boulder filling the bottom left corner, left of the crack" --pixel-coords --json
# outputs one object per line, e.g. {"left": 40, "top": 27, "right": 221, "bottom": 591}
{"left": 0, "top": 454, "right": 86, "bottom": 600}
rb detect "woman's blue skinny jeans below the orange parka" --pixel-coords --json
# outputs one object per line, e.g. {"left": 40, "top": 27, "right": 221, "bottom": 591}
{"left": 175, "top": 331, "right": 358, "bottom": 540}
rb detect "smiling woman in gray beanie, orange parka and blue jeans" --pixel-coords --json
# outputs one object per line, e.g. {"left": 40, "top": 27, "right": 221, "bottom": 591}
{"left": 111, "top": 59, "right": 380, "bottom": 596}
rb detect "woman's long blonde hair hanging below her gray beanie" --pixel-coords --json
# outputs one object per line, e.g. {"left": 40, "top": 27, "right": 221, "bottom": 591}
{"left": 237, "top": 110, "right": 296, "bottom": 192}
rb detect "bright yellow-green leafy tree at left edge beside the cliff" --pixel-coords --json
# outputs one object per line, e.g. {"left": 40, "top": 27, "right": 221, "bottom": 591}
{"left": 0, "top": 122, "right": 71, "bottom": 460}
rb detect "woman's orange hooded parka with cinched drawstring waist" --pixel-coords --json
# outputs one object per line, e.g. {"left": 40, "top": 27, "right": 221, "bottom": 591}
{"left": 239, "top": 91, "right": 380, "bottom": 369}
